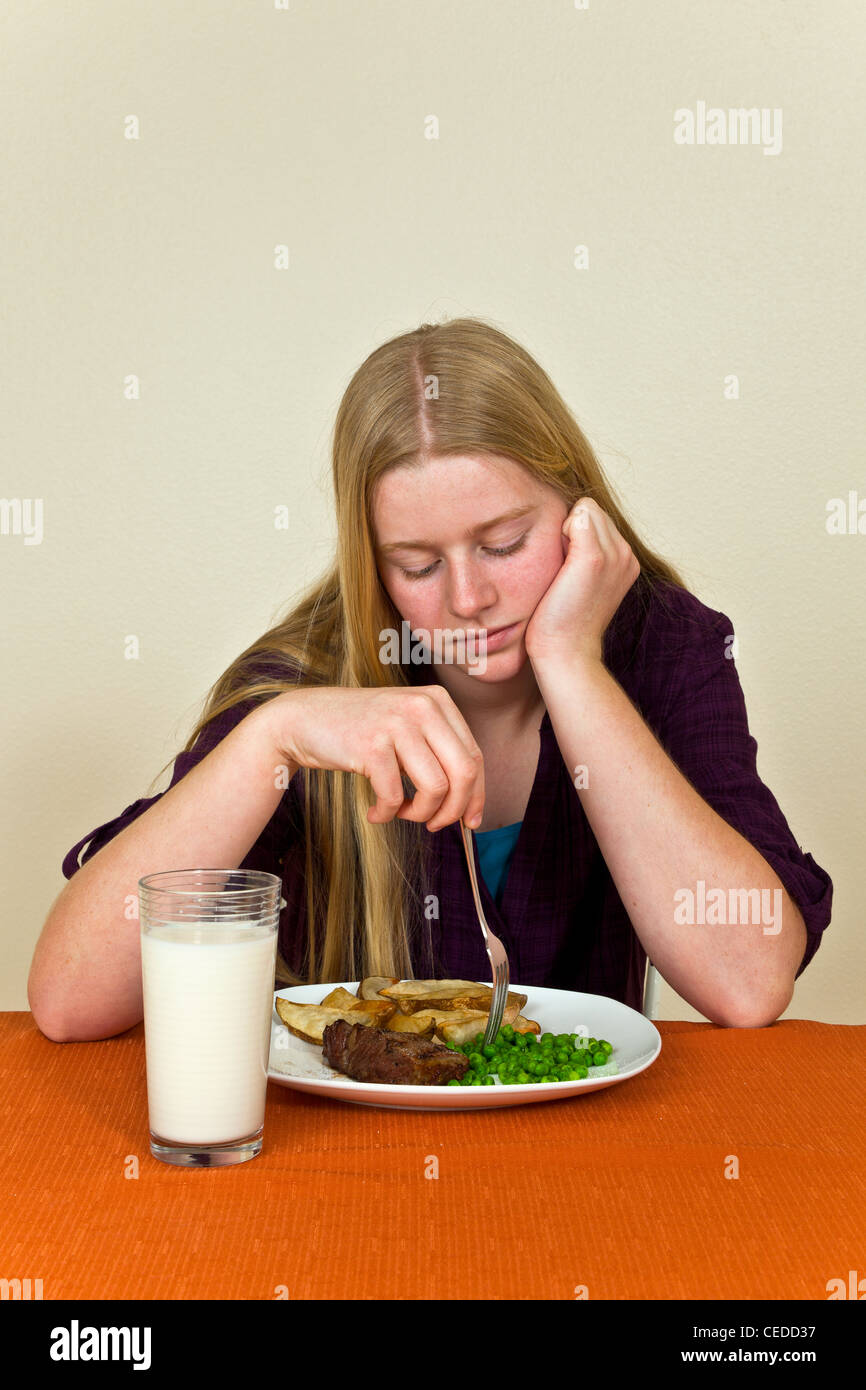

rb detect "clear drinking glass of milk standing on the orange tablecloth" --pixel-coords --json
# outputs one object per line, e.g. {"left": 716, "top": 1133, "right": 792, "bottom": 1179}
{"left": 139, "top": 869, "right": 281, "bottom": 1168}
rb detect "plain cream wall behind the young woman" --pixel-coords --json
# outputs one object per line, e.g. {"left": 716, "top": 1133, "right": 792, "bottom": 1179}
{"left": 0, "top": 0, "right": 866, "bottom": 1023}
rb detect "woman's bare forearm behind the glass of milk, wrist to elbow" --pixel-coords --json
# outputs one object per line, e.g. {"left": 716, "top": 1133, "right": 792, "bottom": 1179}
{"left": 28, "top": 706, "right": 296, "bottom": 1041}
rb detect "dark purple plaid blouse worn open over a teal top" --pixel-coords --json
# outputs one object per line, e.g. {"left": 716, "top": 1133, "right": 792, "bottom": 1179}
{"left": 63, "top": 575, "right": 833, "bottom": 1009}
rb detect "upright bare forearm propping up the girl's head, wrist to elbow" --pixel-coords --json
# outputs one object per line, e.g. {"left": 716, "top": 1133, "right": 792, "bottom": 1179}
{"left": 535, "top": 656, "right": 806, "bottom": 1027}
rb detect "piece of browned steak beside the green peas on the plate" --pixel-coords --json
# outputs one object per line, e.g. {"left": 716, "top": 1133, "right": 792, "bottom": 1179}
{"left": 322, "top": 1019, "right": 468, "bottom": 1086}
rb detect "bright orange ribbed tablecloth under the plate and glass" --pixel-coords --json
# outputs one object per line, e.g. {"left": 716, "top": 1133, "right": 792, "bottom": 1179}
{"left": 0, "top": 1013, "right": 866, "bottom": 1300}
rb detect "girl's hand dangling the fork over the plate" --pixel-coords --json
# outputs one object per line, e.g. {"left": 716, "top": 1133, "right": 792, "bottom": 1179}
{"left": 264, "top": 684, "right": 484, "bottom": 831}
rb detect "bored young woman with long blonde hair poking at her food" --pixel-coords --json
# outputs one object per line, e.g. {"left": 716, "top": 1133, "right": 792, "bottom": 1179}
{"left": 29, "top": 318, "right": 833, "bottom": 1040}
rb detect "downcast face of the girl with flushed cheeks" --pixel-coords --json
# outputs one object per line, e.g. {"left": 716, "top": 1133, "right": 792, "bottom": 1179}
{"left": 373, "top": 457, "right": 569, "bottom": 680}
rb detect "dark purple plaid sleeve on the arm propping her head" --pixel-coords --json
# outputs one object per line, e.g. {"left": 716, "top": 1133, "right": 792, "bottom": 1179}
{"left": 657, "top": 598, "right": 833, "bottom": 976}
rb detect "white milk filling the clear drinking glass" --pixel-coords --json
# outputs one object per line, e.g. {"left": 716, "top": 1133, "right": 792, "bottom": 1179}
{"left": 142, "top": 922, "right": 277, "bottom": 1144}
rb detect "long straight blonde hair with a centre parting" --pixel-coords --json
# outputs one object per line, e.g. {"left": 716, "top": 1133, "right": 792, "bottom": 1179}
{"left": 152, "top": 318, "right": 684, "bottom": 984}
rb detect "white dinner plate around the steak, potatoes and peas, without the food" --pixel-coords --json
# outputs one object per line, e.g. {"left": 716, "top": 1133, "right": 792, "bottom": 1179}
{"left": 268, "top": 980, "right": 662, "bottom": 1111}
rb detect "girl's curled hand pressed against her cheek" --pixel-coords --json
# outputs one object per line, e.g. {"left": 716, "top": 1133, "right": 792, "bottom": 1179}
{"left": 524, "top": 498, "right": 641, "bottom": 663}
